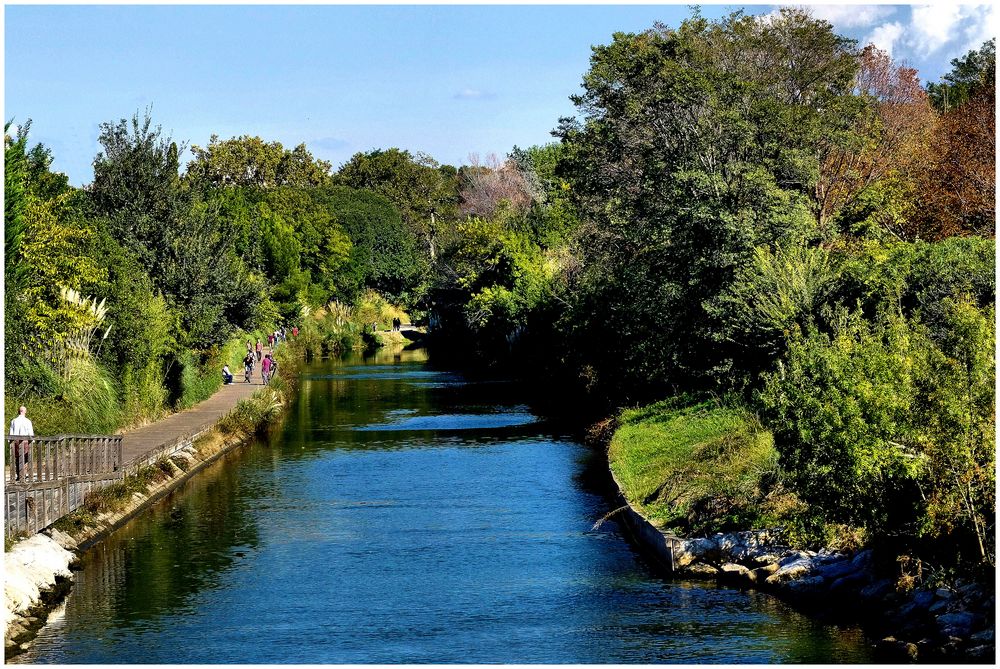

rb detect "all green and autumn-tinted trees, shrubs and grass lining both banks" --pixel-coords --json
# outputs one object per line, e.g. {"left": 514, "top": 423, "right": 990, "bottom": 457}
{"left": 5, "top": 9, "right": 996, "bottom": 648}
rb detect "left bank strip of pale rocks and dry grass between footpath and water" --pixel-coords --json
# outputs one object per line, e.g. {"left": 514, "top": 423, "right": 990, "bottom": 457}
{"left": 4, "top": 342, "right": 302, "bottom": 658}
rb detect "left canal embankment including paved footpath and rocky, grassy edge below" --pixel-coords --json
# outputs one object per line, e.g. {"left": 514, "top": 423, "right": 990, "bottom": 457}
{"left": 4, "top": 345, "right": 302, "bottom": 657}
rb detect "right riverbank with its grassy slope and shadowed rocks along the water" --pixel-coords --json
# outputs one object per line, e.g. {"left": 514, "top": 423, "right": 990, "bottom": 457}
{"left": 594, "top": 403, "right": 995, "bottom": 663}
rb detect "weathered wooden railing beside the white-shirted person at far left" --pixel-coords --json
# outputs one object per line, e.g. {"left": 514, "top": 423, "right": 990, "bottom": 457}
{"left": 4, "top": 434, "right": 122, "bottom": 535}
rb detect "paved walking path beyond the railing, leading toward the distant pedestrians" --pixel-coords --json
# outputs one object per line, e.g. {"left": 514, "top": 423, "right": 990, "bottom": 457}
{"left": 122, "top": 348, "right": 271, "bottom": 469}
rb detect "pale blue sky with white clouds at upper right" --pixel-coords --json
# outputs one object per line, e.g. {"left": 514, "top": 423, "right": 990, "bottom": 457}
{"left": 3, "top": 3, "right": 996, "bottom": 185}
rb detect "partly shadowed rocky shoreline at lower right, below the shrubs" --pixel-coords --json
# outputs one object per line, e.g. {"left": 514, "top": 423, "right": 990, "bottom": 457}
{"left": 670, "top": 530, "right": 996, "bottom": 664}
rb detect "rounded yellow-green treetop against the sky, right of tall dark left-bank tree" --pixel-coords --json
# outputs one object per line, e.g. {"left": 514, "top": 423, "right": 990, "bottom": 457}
{"left": 185, "top": 135, "right": 330, "bottom": 188}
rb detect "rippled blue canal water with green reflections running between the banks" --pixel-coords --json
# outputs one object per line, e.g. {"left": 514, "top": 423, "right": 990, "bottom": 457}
{"left": 15, "top": 350, "right": 870, "bottom": 664}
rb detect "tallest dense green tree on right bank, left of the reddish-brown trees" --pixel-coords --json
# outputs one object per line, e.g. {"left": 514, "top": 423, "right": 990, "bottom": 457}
{"left": 556, "top": 9, "right": 859, "bottom": 399}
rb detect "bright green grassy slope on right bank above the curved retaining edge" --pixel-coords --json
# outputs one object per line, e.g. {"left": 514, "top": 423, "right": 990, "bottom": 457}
{"left": 608, "top": 398, "right": 797, "bottom": 535}
